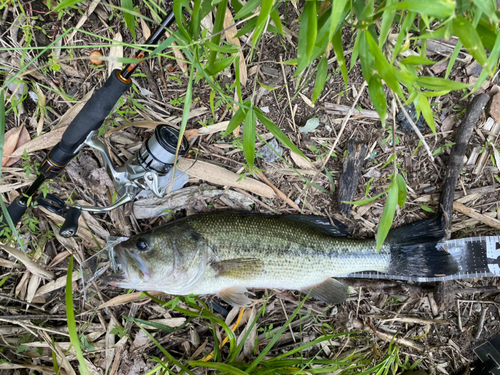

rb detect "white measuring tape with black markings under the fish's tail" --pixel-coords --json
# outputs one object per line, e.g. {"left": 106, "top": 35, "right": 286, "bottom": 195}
{"left": 343, "top": 236, "right": 500, "bottom": 282}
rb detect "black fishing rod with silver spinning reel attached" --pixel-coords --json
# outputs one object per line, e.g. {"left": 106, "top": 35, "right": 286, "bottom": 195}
{"left": 0, "top": 12, "right": 189, "bottom": 237}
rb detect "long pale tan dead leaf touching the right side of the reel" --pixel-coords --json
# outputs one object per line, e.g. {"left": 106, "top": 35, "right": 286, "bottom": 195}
{"left": 177, "top": 158, "right": 276, "bottom": 198}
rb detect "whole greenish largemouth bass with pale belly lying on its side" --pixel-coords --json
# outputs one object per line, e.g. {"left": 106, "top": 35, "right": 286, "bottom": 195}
{"left": 110, "top": 212, "right": 458, "bottom": 306}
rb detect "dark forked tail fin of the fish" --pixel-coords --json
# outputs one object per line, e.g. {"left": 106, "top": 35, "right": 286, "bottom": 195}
{"left": 387, "top": 214, "right": 458, "bottom": 277}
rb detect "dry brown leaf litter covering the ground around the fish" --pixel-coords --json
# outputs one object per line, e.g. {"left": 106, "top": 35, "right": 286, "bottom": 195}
{"left": 0, "top": 2, "right": 500, "bottom": 374}
